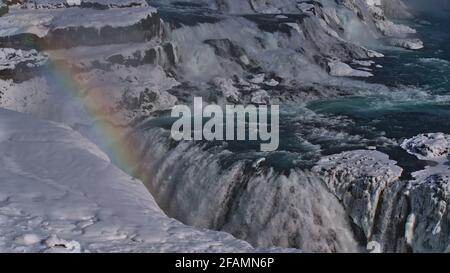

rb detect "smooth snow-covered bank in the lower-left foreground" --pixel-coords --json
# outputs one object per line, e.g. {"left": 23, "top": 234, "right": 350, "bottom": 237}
{"left": 0, "top": 109, "right": 258, "bottom": 252}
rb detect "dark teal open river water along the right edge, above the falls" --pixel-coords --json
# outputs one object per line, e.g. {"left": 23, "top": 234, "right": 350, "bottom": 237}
{"left": 307, "top": 14, "right": 450, "bottom": 172}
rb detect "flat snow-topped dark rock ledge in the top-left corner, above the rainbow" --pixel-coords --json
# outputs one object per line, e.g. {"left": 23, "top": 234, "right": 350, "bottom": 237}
{"left": 0, "top": 6, "right": 160, "bottom": 48}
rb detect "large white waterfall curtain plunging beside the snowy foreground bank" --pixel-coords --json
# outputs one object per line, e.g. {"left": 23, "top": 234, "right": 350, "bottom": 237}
{"left": 125, "top": 125, "right": 358, "bottom": 252}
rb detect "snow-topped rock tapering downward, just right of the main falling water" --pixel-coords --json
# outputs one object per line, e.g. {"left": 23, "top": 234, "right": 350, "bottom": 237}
{"left": 313, "top": 150, "right": 403, "bottom": 239}
